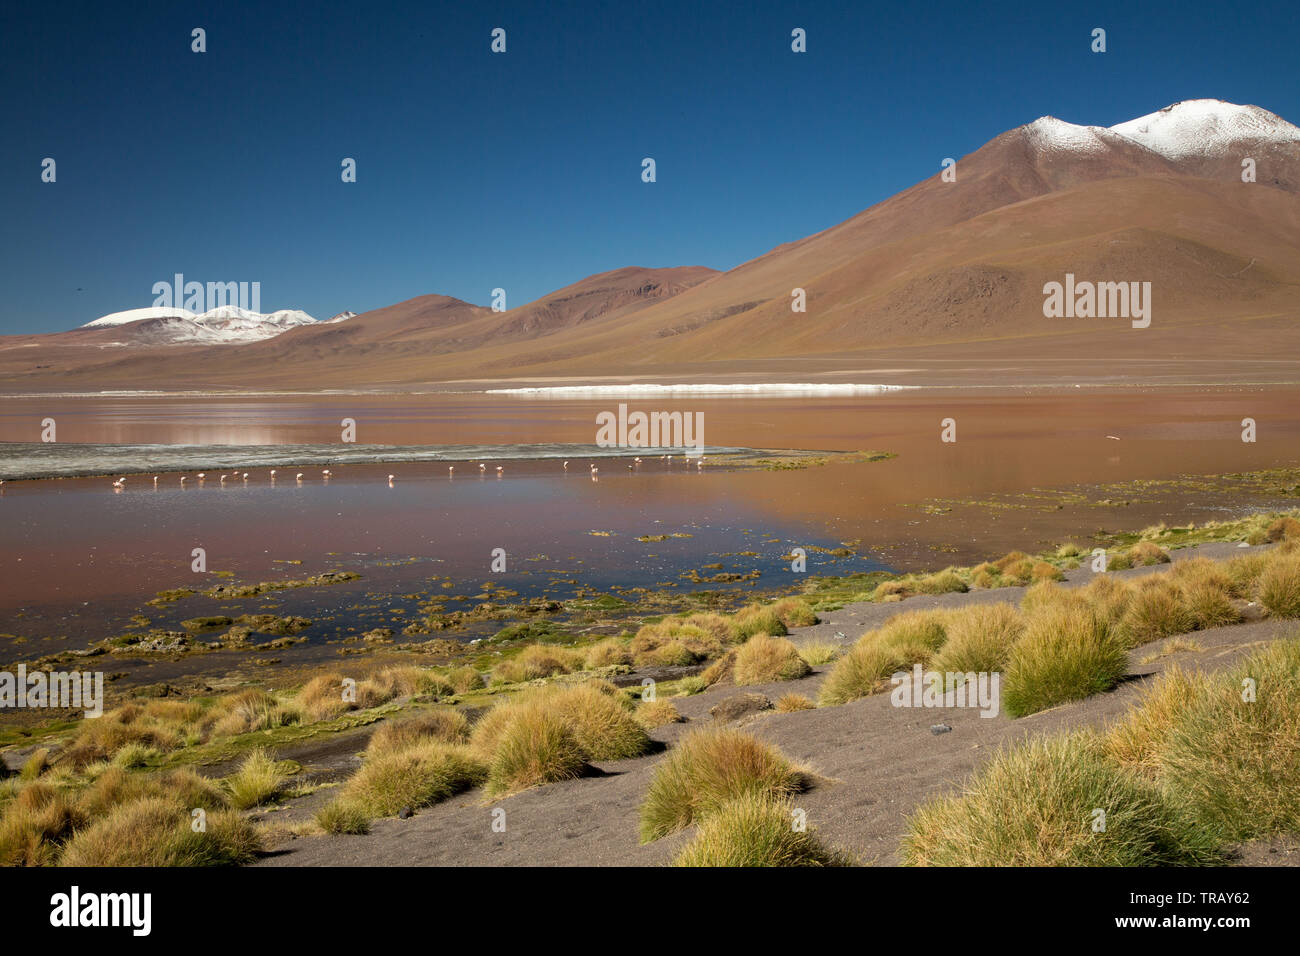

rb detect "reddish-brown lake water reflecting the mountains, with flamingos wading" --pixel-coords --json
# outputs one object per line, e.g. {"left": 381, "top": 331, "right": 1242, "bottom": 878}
{"left": 0, "top": 388, "right": 1300, "bottom": 671}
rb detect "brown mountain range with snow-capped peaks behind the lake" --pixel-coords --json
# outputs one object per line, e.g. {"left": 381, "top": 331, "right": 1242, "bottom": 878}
{"left": 0, "top": 100, "right": 1300, "bottom": 390}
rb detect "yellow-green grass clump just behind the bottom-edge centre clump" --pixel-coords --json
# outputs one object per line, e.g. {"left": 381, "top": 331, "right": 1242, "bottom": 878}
{"left": 641, "top": 727, "right": 803, "bottom": 843}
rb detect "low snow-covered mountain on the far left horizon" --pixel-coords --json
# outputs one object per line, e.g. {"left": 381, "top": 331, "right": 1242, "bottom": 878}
{"left": 82, "top": 306, "right": 355, "bottom": 345}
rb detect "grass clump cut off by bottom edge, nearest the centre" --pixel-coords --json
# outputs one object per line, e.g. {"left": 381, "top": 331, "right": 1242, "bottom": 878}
{"left": 673, "top": 793, "right": 853, "bottom": 866}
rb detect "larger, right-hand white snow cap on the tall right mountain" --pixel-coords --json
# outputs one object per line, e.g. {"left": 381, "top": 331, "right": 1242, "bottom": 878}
{"left": 1110, "top": 100, "right": 1300, "bottom": 160}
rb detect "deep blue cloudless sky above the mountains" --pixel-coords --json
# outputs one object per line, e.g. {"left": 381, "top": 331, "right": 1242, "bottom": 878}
{"left": 0, "top": 0, "right": 1300, "bottom": 333}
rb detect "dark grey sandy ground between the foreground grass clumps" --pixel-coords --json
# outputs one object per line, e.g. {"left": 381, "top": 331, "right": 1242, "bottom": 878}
{"left": 250, "top": 545, "right": 1300, "bottom": 866}
